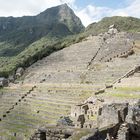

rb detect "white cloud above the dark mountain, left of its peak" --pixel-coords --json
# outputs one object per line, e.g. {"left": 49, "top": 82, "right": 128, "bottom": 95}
{"left": 0, "top": 0, "right": 75, "bottom": 17}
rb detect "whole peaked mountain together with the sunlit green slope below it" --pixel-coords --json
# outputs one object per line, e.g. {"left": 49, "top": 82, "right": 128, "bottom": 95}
{"left": 0, "top": 4, "right": 84, "bottom": 77}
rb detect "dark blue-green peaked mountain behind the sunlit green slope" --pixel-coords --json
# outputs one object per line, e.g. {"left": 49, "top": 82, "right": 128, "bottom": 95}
{"left": 0, "top": 4, "right": 84, "bottom": 56}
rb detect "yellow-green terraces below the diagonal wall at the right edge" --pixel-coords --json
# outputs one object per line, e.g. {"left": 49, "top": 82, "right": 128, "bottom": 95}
{"left": 97, "top": 68, "right": 140, "bottom": 104}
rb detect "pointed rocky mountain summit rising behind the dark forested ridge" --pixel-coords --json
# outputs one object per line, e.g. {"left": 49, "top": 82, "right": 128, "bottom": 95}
{"left": 37, "top": 3, "right": 84, "bottom": 33}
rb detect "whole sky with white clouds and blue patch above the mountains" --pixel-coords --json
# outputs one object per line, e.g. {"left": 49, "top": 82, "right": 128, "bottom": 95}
{"left": 0, "top": 0, "right": 140, "bottom": 26}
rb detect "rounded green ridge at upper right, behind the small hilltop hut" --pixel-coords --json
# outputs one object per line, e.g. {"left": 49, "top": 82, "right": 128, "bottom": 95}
{"left": 85, "top": 16, "right": 140, "bottom": 35}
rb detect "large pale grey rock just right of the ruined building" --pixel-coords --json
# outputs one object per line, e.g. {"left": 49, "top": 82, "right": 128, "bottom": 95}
{"left": 98, "top": 103, "right": 128, "bottom": 128}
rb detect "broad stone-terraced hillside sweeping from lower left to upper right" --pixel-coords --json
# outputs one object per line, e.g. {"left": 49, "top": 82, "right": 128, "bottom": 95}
{"left": 0, "top": 33, "right": 140, "bottom": 139}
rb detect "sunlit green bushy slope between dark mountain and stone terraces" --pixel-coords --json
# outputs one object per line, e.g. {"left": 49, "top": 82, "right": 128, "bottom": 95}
{"left": 0, "top": 35, "right": 83, "bottom": 77}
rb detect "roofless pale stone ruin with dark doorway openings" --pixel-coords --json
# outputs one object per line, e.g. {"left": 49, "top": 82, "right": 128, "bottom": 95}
{"left": 71, "top": 97, "right": 103, "bottom": 128}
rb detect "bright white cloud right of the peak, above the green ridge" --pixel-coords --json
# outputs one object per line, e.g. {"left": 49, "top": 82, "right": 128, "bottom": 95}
{"left": 76, "top": 0, "right": 140, "bottom": 26}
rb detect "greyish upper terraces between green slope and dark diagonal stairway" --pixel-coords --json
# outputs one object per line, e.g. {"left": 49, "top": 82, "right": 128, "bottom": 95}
{"left": 25, "top": 37, "right": 101, "bottom": 83}
